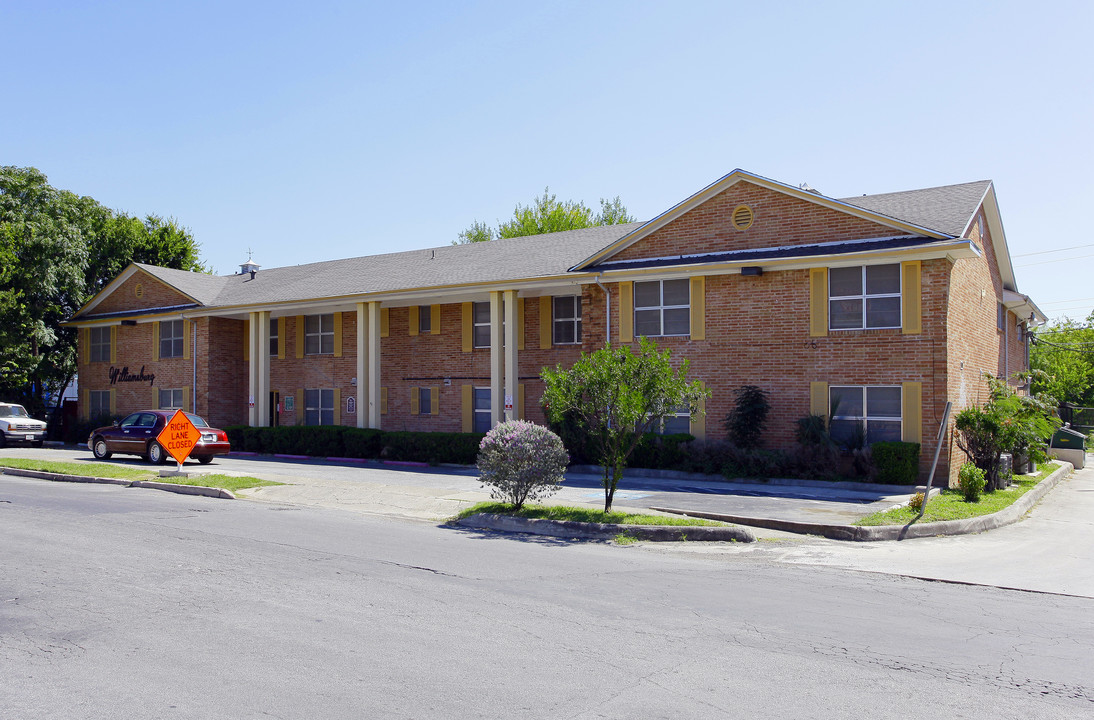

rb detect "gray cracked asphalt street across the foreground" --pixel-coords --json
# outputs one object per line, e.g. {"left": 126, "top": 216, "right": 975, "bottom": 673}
{"left": 0, "top": 476, "right": 1094, "bottom": 720}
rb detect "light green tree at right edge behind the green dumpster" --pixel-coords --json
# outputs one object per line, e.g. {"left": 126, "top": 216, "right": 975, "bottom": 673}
{"left": 1029, "top": 312, "right": 1094, "bottom": 407}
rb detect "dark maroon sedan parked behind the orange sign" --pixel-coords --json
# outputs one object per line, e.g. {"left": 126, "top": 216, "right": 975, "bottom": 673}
{"left": 88, "top": 410, "right": 232, "bottom": 465}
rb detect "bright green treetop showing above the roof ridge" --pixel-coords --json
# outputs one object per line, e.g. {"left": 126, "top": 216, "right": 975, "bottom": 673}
{"left": 453, "top": 188, "right": 635, "bottom": 245}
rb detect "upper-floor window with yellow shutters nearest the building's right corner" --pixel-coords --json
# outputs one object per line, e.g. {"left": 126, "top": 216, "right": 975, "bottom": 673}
{"left": 828, "top": 264, "right": 900, "bottom": 330}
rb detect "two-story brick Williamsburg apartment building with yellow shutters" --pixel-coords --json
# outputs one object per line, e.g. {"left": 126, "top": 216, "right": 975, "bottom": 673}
{"left": 71, "top": 170, "right": 1045, "bottom": 477}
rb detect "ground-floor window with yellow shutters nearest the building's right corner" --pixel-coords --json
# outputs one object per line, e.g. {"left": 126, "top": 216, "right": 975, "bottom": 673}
{"left": 828, "top": 385, "right": 901, "bottom": 446}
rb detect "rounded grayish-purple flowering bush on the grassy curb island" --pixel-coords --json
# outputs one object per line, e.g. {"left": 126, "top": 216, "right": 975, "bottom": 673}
{"left": 477, "top": 420, "right": 570, "bottom": 510}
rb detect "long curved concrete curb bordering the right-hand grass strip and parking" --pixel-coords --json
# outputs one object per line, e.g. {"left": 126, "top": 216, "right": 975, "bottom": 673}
{"left": 651, "top": 463, "right": 1074, "bottom": 543}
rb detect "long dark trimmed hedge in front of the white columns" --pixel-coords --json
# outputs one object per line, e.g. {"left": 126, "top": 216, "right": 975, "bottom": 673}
{"left": 224, "top": 425, "right": 482, "bottom": 465}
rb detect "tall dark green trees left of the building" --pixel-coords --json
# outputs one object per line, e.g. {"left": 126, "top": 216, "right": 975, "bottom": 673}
{"left": 0, "top": 166, "right": 207, "bottom": 413}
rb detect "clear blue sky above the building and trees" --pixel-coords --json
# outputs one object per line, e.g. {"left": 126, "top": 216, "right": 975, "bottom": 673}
{"left": 0, "top": 0, "right": 1094, "bottom": 317}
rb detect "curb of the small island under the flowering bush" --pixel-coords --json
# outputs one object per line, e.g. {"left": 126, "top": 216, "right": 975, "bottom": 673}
{"left": 456, "top": 513, "right": 756, "bottom": 543}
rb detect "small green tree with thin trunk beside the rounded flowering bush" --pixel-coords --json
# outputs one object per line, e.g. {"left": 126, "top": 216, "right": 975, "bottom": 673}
{"left": 542, "top": 337, "right": 710, "bottom": 512}
